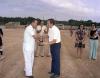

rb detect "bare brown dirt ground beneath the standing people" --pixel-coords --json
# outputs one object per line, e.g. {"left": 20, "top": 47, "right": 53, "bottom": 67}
{"left": 0, "top": 29, "right": 100, "bottom": 78}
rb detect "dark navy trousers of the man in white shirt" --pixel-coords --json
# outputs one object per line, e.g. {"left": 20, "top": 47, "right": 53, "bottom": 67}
{"left": 50, "top": 43, "right": 61, "bottom": 75}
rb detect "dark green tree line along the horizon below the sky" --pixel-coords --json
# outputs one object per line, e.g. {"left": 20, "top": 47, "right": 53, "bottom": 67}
{"left": 0, "top": 17, "right": 100, "bottom": 26}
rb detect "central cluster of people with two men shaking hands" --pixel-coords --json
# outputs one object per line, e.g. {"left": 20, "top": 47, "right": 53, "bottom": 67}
{"left": 23, "top": 19, "right": 61, "bottom": 78}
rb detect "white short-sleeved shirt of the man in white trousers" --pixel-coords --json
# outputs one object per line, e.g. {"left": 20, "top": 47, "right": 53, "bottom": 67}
{"left": 23, "top": 25, "right": 36, "bottom": 50}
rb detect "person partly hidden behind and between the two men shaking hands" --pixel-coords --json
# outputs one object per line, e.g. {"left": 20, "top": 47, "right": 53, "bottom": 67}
{"left": 35, "top": 19, "right": 50, "bottom": 57}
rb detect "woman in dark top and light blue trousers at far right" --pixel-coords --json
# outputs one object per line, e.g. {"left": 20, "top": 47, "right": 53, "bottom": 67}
{"left": 89, "top": 24, "right": 99, "bottom": 60}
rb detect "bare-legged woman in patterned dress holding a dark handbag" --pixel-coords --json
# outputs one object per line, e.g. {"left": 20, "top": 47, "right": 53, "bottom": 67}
{"left": 75, "top": 25, "right": 85, "bottom": 58}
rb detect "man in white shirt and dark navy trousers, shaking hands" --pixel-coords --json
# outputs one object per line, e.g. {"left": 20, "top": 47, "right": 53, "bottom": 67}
{"left": 44, "top": 19, "right": 61, "bottom": 78}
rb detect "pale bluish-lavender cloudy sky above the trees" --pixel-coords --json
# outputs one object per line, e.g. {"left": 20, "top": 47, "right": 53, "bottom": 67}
{"left": 0, "top": 0, "right": 100, "bottom": 22}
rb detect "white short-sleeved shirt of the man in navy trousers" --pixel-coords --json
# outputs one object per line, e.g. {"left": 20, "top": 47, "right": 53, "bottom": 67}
{"left": 48, "top": 25, "right": 61, "bottom": 43}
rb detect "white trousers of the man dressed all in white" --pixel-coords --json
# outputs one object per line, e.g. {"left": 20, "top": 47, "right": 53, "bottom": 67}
{"left": 23, "top": 46, "right": 34, "bottom": 76}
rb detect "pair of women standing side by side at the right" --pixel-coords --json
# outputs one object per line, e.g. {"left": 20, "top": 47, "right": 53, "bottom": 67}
{"left": 70, "top": 24, "right": 100, "bottom": 60}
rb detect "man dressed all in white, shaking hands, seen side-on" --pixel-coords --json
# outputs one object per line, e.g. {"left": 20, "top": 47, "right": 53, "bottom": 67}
{"left": 23, "top": 19, "right": 37, "bottom": 78}
